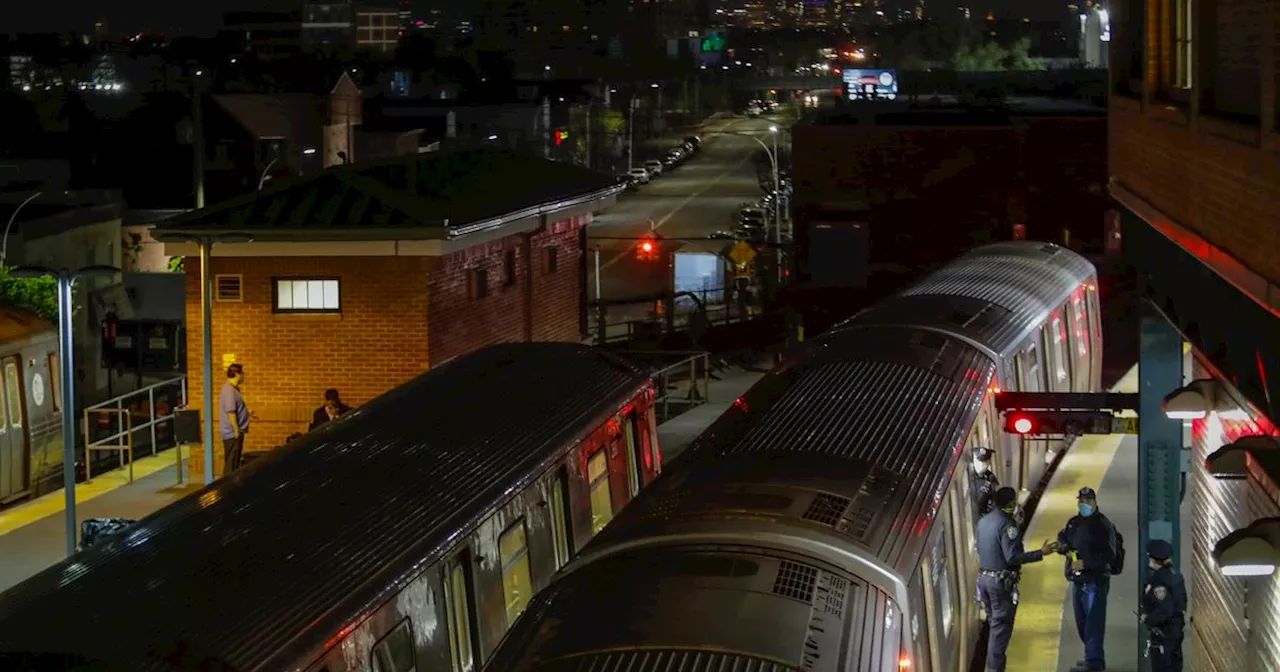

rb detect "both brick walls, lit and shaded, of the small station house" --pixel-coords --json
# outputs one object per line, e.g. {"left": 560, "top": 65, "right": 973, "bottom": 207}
{"left": 187, "top": 216, "right": 589, "bottom": 477}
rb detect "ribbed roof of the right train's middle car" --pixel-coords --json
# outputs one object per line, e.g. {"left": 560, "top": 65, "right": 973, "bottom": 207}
{"left": 600, "top": 326, "right": 996, "bottom": 566}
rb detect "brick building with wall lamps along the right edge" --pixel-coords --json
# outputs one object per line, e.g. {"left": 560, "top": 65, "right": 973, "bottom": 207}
{"left": 1108, "top": 0, "right": 1280, "bottom": 669}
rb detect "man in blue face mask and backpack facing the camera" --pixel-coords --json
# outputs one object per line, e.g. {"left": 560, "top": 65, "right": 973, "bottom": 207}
{"left": 1057, "top": 488, "right": 1119, "bottom": 672}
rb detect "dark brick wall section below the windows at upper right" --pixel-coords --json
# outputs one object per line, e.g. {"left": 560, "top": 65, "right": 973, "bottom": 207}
{"left": 1110, "top": 96, "right": 1280, "bottom": 282}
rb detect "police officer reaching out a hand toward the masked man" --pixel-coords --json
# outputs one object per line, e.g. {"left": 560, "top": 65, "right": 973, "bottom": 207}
{"left": 978, "top": 488, "right": 1057, "bottom": 672}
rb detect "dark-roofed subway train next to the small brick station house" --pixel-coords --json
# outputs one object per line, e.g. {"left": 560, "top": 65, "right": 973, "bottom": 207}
{"left": 0, "top": 343, "right": 660, "bottom": 672}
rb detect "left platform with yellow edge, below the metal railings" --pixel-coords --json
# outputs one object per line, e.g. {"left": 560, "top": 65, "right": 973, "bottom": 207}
{"left": 0, "top": 447, "right": 204, "bottom": 591}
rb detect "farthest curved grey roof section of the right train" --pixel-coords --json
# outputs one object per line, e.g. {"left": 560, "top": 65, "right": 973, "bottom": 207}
{"left": 836, "top": 241, "right": 1096, "bottom": 357}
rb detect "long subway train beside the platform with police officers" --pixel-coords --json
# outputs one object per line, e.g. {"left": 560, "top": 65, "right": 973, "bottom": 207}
{"left": 483, "top": 242, "right": 1102, "bottom": 672}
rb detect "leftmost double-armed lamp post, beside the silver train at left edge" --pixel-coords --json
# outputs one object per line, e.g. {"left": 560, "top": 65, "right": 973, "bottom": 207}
{"left": 12, "top": 265, "right": 120, "bottom": 556}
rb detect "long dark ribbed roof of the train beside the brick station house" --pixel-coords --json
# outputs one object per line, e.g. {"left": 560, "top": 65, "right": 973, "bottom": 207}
{"left": 0, "top": 343, "right": 649, "bottom": 672}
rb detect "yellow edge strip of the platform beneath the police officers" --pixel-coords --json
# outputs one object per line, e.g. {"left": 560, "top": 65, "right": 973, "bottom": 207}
{"left": 1006, "top": 366, "right": 1138, "bottom": 672}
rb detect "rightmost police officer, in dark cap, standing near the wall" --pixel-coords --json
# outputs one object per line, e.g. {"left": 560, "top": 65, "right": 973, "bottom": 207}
{"left": 1140, "top": 539, "right": 1187, "bottom": 672}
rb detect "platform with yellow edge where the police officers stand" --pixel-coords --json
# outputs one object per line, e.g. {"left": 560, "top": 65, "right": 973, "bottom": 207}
{"left": 1006, "top": 366, "right": 1192, "bottom": 672}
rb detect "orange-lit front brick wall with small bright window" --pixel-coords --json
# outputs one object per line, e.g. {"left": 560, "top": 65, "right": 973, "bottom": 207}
{"left": 187, "top": 257, "right": 428, "bottom": 479}
